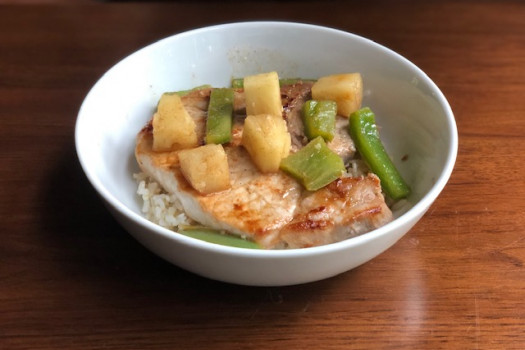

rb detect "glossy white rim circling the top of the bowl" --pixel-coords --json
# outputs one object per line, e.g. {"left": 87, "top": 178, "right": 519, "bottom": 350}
{"left": 74, "top": 21, "right": 458, "bottom": 259}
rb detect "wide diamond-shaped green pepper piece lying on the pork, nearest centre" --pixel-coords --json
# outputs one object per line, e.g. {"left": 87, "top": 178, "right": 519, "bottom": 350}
{"left": 280, "top": 136, "right": 345, "bottom": 191}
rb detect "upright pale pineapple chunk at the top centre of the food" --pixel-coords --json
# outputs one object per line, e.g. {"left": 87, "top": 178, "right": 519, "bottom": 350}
{"left": 244, "top": 72, "right": 283, "bottom": 117}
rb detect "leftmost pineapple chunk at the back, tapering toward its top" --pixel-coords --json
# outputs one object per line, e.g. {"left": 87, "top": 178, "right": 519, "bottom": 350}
{"left": 153, "top": 94, "right": 197, "bottom": 152}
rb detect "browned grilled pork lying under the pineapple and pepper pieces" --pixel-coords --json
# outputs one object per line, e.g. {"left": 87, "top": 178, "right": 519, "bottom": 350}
{"left": 135, "top": 87, "right": 392, "bottom": 249}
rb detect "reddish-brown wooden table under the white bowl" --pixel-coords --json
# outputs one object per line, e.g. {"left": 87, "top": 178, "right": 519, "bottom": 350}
{"left": 0, "top": 1, "right": 525, "bottom": 350}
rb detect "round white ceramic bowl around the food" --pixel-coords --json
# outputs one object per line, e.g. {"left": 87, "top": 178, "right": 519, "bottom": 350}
{"left": 75, "top": 22, "right": 458, "bottom": 286}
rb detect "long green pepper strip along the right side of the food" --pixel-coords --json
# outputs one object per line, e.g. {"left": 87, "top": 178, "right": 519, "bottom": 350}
{"left": 348, "top": 107, "right": 410, "bottom": 200}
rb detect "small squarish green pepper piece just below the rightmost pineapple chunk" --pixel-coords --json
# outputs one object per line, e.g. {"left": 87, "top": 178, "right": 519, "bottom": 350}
{"left": 301, "top": 100, "right": 337, "bottom": 141}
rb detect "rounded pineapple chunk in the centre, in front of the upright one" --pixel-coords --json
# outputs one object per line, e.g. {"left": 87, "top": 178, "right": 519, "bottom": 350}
{"left": 242, "top": 114, "right": 291, "bottom": 173}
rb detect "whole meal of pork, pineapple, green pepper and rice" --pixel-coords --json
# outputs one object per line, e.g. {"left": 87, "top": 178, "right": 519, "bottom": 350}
{"left": 135, "top": 72, "right": 409, "bottom": 249}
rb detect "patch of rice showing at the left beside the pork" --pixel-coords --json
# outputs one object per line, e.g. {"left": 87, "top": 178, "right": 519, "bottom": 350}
{"left": 133, "top": 173, "right": 194, "bottom": 231}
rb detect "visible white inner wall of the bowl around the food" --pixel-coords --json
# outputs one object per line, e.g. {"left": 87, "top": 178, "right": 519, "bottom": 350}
{"left": 76, "top": 22, "right": 457, "bottom": 250}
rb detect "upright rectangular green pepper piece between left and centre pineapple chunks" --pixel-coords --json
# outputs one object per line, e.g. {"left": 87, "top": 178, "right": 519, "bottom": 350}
{"left": 206, "top": 88, "right": 233, "bottom": 144}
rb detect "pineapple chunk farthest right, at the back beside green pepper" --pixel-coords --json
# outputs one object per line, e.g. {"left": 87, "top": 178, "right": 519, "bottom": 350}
{"left": 312, "top": 73, "right": 363, "bottom": 118}
